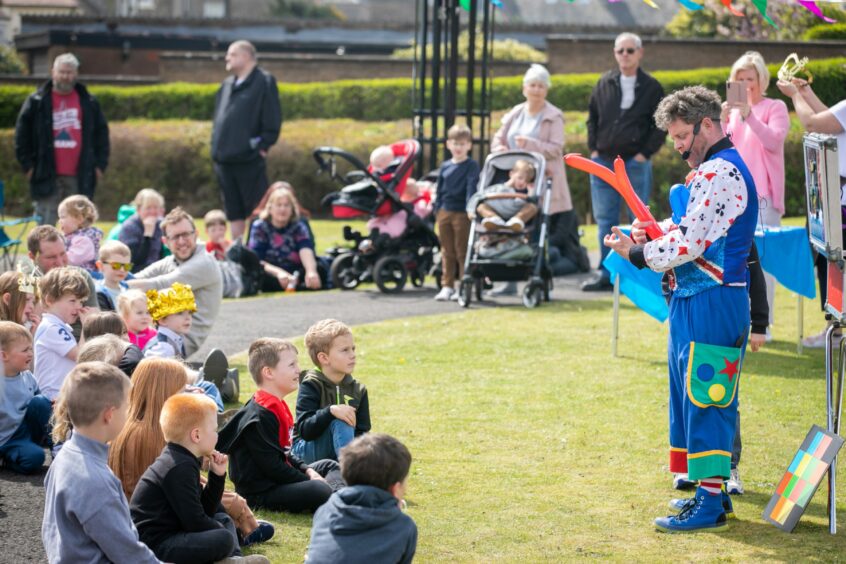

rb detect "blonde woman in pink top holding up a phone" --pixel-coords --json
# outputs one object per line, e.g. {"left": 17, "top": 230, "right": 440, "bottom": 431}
{"left": 720, "top": 51, "right": 790, "bottom": 341}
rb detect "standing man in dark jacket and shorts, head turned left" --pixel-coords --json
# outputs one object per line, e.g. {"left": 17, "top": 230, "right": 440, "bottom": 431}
{"left": 211, "top": 40, "right": 282, "bottom": 240}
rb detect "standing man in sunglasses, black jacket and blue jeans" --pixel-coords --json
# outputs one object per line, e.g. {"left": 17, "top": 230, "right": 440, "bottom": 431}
{"left": 582, "top": 33, "right": 666, "bottom": 292}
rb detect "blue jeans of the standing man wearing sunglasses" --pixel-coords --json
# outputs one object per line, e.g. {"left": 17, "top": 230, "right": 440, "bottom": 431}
{"left": 590, "top": 157, "right": 652, "bottom": 279}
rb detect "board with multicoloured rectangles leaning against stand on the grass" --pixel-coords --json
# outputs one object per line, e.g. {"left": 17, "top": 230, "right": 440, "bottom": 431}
{"left": 764, "top": 425, "right": 843, "bottom": 533}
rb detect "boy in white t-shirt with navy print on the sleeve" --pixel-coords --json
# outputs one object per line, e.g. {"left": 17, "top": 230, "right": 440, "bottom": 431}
{"left": 35, "top": 267, "right": 88, "bottom": 401}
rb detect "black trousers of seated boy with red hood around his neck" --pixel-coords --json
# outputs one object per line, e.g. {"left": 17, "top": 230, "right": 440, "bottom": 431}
{"left": 244, "top": 459, "right": 345, "bottom": 513}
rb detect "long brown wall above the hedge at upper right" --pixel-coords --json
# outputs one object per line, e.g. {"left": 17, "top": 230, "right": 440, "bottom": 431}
{"left": 546, "top": 35, "right": 846, "bottom": 74}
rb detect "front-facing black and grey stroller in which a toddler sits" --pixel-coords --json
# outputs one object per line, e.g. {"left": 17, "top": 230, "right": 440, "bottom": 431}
{"left": 458, "top": 151, "right": 552, "bottom": 308}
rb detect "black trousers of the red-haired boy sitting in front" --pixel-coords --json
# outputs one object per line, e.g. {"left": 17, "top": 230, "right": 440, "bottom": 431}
{"left": 153, "top": 508, "right": 241, "bottom": 564}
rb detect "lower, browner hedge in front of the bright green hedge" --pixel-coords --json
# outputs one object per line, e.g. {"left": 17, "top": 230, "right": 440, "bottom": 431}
{"left": 0, "top": 112, "right": 816, "bottom": 225}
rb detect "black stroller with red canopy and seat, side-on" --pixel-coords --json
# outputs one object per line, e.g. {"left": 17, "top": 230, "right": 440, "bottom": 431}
{"left": 314, "top": 140, "right": 438, "bottom": 294}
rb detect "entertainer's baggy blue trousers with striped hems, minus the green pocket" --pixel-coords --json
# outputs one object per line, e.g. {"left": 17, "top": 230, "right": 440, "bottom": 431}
{"left": 667, "top": 286, "right": 749, "bottom": 480}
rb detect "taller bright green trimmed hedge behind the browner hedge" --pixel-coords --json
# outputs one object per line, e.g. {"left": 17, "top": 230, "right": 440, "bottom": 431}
{"left": 0, "top": 58, "right": 846, "bottom": 127}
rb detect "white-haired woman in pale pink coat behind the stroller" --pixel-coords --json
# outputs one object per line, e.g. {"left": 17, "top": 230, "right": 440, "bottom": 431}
{"left": 491, "top": 64, "right": 573, "bottom": 295}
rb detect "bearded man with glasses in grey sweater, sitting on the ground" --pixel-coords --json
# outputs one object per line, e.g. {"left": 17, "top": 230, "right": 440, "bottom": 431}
{"left": 127, "top": 208, "right": 223, "bottom": 356}
